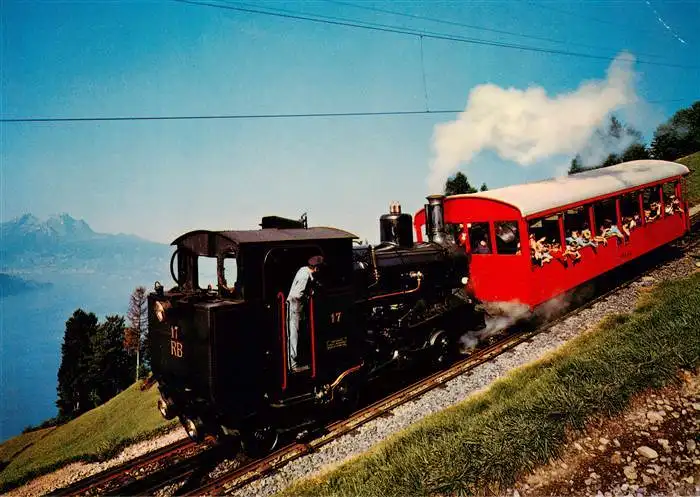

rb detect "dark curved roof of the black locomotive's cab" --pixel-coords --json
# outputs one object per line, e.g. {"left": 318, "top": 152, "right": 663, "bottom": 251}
{"left": 171, "top": 227, "right": 357, "bottom": 257}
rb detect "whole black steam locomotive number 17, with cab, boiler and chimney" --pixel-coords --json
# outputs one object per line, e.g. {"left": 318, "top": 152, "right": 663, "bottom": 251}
{"left": 149, "top": 196, "right": 483, "bottom": 452}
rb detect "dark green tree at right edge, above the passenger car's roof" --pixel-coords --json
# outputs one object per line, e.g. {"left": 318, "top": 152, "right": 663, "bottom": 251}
{"left": 651, "top": 101, "right": 700, "bottom": 160}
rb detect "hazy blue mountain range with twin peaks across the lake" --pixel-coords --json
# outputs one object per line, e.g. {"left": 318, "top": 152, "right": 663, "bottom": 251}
{"left": 0, "top": 214, "right": 170, "bottom": 271}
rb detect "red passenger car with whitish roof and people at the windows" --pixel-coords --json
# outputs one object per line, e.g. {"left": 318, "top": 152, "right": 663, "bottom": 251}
{"left": 414, "top": 160, "right": 689, "bottom": 308}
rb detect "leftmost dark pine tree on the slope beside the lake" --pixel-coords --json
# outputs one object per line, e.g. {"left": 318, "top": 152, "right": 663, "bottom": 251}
{"left": 56, "top": 309, "right": 97, "bottom": 419}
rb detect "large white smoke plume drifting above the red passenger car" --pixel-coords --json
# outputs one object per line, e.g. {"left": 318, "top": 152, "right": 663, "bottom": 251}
{"left": 428, "top": 52, "right": 638, "bottom": 192}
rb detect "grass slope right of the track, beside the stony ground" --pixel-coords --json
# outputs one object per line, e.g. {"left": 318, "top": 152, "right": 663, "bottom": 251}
{"left": 284, "top": 273, "right": 700, "bottom": 497}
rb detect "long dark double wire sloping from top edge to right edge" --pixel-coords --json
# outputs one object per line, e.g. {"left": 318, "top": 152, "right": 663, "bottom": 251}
{"left": 172, "top": 0, "right": 700, "bottom": 69}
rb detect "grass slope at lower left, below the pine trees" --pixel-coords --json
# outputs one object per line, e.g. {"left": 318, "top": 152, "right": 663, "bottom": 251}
{"left": 0, "top": 383, "right": 176, "bottom": 492}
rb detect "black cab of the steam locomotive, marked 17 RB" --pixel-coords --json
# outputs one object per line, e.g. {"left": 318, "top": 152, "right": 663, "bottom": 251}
{"left": 149, "top": 218, "right": 361, "bottom": 438}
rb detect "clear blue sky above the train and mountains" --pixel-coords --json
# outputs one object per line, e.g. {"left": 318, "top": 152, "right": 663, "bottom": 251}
{"left": 0, "top": 0, "right": 700, "bottom": 242}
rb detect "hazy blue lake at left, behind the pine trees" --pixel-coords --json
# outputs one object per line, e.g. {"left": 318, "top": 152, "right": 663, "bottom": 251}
{"left": 0, "top": 268, "right": 171, "bottom": 441}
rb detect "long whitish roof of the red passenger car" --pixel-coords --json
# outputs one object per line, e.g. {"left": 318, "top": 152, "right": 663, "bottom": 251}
{"left": 448, "top": 160, "right": 690, "bottom": 217}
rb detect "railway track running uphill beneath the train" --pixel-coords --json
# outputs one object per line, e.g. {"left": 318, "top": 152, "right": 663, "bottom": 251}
{"left": 52, "top": 213, "right": 700, "bottom": 495}
